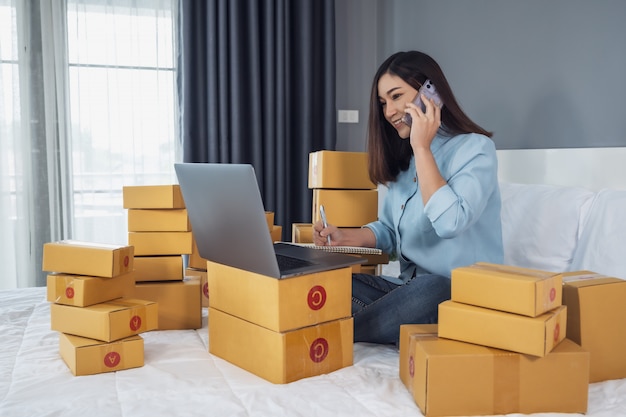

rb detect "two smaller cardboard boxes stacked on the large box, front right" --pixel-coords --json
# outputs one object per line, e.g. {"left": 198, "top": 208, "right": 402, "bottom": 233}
{"left": 439, "top": 263, "right": 567, "bottom": 356}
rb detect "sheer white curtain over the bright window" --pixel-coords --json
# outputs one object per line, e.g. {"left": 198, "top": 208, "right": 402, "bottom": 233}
{"left": 0, "top": 0, "right": 181, "bottom": 288}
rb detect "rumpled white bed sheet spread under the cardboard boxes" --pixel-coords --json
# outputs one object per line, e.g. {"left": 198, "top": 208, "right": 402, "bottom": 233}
{"left": 0, "top": 287, "right": 626, "bottom": 417}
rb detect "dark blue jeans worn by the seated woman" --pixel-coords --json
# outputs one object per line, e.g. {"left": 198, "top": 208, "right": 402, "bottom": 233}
{"left": 352, "top": 274, "right": 450, "bottom": 344}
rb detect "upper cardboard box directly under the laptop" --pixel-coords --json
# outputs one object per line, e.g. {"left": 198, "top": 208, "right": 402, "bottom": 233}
{"left": 207, "top": 261, "right": 352, "bottom": 332}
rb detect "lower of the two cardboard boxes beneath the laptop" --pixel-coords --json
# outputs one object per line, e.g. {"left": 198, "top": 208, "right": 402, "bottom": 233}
{"left": 208, "top": 307, "right": 354, "bottom": 384}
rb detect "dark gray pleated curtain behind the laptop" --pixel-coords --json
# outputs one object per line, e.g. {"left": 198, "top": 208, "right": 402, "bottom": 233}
{"left": 179, "top": 0, "right": 336, "bottom": 240}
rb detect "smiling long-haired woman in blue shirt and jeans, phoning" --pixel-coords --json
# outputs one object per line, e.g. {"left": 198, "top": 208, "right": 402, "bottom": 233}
{"left": 314, "top": 51, "right": 503, "bottom": 343}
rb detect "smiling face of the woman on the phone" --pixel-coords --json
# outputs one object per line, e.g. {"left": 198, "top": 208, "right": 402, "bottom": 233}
{"left": 378, "top": 74, "right": 417, "bottom": 139}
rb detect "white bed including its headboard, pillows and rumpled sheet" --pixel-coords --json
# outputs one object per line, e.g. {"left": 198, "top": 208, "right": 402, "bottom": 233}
{"left": 7, "top": 148, "right": 626, "bottom": 417}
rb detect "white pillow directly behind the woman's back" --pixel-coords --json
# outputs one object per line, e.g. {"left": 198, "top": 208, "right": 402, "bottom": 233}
{"left": 500, "top": 183, "right": 595, "bottom": 272}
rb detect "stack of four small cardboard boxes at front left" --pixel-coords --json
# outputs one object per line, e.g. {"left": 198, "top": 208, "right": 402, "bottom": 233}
{"left": 42, "top": 240, "right": 158, "bottom": 375}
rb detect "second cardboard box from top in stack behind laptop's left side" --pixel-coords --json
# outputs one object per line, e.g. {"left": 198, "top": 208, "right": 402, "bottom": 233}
{"left": 127, "top": 209, "right": 191, "bottom": 232}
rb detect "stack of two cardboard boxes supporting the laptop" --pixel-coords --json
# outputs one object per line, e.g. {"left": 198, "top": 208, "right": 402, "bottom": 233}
{"left": 207, "top": 261, "right": 353, "bottom": 384}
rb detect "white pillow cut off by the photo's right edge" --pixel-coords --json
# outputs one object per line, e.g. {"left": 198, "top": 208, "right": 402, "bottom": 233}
{"left": 570, "top": 189, "right": 626, "bottom": 279}
